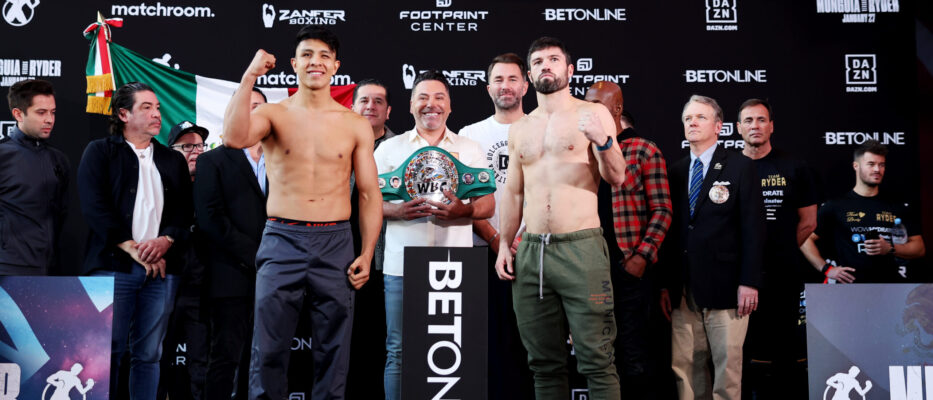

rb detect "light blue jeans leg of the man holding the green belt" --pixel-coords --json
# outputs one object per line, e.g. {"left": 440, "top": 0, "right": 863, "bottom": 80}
{"left": 383, "top": 275, "right": 404, "bottom": 400}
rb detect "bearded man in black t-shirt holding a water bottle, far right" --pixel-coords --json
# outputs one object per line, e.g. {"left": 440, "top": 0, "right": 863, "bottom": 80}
{"left": 800, "top": 140, "right": 926, "bottom": 283}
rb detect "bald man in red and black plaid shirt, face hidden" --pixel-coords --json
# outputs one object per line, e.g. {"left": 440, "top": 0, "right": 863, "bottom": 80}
{"left": 585, "top": 81, "right": 671, "bottom": 399}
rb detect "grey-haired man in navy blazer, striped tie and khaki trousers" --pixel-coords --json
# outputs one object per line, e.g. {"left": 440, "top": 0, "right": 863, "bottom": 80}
{"left": 661, "top": 95, "right": 765, "bottom": 400}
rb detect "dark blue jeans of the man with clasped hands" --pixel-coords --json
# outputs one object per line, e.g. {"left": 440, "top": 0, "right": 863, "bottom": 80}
{"left": 95, "top": 263, "right": 178, "bottom": 400}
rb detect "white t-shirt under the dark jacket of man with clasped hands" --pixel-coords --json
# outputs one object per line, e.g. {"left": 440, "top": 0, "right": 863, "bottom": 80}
{"left": 126, "top": 142, "right": 165, "bottom": 243}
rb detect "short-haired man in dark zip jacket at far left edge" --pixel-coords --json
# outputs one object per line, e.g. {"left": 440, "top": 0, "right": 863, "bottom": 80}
{"left": 0, "top": 80, "right": 71, "bottom": 275}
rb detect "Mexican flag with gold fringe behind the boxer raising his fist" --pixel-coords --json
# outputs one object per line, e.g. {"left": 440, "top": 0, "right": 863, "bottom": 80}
{"left": 84, "top": 13, "right": 356, "bottom": 148}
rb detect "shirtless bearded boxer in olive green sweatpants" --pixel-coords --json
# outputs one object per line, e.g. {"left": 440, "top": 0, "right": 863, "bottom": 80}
{"left": 496, "top": 37, "right": 625, "bottom": 400}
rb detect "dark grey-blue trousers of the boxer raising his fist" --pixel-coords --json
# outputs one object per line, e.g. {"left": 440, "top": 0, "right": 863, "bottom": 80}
{"left": 249, "top": 221, "right": 354, "bottom": 400}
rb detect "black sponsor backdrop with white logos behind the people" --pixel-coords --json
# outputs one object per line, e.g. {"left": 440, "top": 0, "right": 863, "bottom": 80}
{"left": 0, "top": 0, "right": 920, "bottom": 398}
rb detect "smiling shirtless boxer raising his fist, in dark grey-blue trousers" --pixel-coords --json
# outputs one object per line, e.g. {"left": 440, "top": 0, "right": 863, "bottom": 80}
{"left": 223, "top": 26, "right": 382, "bottom": 400}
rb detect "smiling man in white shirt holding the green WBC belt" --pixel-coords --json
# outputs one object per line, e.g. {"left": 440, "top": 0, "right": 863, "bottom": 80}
{"left": 375, "top": 70, "right": 495, "bottom": 400}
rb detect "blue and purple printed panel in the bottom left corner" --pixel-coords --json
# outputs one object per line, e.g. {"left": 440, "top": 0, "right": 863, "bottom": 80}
{"left": 0, "top": 277, "right": 113, "bottom": 400}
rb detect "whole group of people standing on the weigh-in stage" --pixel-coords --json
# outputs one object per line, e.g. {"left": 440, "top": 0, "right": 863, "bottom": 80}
{"left": 0, "top": 26, "right": 925, "bottom": 399}
